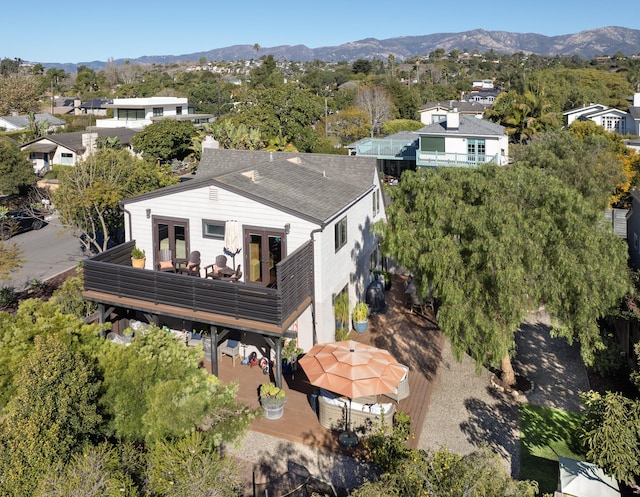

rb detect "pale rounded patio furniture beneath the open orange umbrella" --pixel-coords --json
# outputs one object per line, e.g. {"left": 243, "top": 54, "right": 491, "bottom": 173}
{"left": 318, "top": 389, "right": 396, "bottom": 433}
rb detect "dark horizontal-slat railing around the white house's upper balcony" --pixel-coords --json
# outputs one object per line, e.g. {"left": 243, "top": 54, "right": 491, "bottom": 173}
{"left": 84, "top": 241, "right": 313, "bottom": 326}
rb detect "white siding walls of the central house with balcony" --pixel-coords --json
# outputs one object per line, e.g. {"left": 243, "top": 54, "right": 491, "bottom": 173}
{"left": 125, "top": 175, "right": 385, "bottom": 350}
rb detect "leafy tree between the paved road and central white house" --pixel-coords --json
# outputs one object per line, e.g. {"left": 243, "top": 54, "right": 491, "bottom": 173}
{"left": 54, "top": 148, "right": 176, "bottom": 252}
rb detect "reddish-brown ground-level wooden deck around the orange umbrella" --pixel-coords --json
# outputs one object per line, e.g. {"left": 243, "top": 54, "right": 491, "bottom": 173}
{"left": 206, "top": 276, "right": 443, "bottom": 454}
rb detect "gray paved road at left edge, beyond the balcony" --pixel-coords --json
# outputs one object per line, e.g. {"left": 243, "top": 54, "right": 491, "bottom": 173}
{"left": 0, "top": 213, "right": 85, "bottom": 291}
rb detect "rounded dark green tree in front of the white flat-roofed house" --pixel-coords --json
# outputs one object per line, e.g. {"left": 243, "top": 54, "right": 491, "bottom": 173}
{"left": 131, "top": 119, "right": 198, "bottom": 162}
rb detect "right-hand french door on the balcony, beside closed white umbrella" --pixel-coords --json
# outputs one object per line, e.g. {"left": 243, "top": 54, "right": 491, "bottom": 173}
{"left": 243, "top": 227, "right": 286, "bottom": 288}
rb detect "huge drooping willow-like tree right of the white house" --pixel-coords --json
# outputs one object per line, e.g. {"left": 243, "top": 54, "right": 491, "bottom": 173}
{"left": 380, "top": 165, "right": 629, "bottom": 385}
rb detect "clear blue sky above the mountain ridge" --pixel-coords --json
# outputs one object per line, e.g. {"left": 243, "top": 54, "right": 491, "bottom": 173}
{"left": 5, "top": 0, "right": 640, "bottom": 64}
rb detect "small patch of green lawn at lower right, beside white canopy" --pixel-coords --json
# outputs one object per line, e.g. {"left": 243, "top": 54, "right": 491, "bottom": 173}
{"left": 520, "top": 404, "right": 584, "bottom": 495}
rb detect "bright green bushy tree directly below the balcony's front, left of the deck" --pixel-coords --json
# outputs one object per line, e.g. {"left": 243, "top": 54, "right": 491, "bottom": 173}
{"left": 100, "top": 328, "right": 254, "bottom": 447}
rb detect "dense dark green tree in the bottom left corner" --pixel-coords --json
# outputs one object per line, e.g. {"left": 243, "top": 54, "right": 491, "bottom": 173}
{"left": 0, "top": 331, "right": 101, "bottom": 496}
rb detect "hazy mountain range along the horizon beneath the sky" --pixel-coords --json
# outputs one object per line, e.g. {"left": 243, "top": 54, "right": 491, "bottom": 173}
{"left": 43, "top": 26, "right": 640, "bottom": 72}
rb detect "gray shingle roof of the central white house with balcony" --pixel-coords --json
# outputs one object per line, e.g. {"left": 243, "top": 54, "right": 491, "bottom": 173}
{"left": 124, "top": 149, "right": 377, "bottom": 224}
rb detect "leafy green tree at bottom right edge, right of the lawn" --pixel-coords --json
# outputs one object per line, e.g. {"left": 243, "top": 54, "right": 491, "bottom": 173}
{"left": 580, "top": 391, "right": 640, "bottom": 486}
